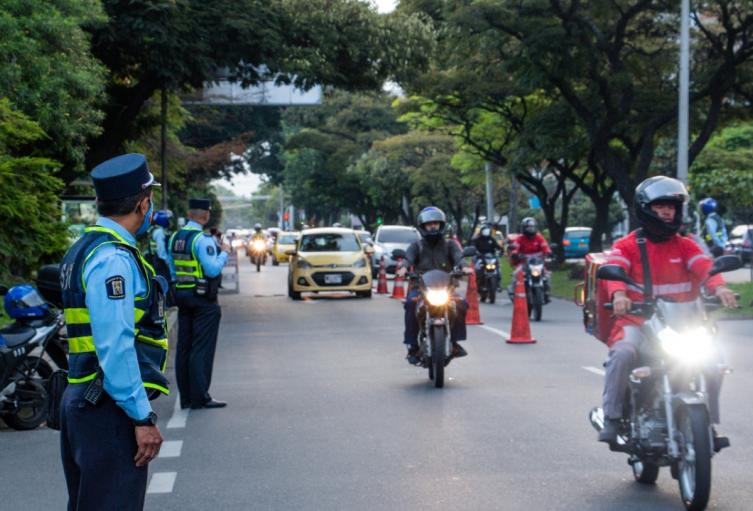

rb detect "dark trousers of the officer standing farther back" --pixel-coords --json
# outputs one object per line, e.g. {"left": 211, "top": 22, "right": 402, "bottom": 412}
{"left": 175, "top": 290, "right": 222, "bottom": 408}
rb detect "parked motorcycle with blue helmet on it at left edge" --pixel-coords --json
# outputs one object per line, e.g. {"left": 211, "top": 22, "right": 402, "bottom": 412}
{"left": 0, "top": 285, "right": 68, "bottom": 430}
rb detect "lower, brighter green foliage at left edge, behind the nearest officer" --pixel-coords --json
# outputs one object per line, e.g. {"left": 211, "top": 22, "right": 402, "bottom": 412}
{"left": 0, "top": 98, "right": 68, "bottom": 280}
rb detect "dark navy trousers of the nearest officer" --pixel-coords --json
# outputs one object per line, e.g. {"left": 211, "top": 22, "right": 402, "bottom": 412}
{"left": 60, "top": 383, "right": 147, "bottom": 511}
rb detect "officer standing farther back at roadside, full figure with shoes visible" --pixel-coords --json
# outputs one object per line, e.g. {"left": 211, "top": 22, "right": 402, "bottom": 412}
{"left": 170, "top": 199, "right": 230, "bottom": 409}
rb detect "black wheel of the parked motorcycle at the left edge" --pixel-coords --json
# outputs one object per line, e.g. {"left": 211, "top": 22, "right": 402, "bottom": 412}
{"left": 3, "top": 357, "right": 52, "bottom": 431}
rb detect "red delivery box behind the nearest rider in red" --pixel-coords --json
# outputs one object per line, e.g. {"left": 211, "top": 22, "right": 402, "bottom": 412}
{"left": 575, "top": 252, "right": 614, "bottom": 343}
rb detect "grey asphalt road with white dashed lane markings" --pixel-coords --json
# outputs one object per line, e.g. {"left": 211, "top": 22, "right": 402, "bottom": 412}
{"left": 0, "top": 259, "right": 753, "bottom": 511}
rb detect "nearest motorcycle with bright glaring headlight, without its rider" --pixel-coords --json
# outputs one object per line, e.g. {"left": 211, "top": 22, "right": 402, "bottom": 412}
{"left": 589, "top": 256, "right": 742, "bottom": 511}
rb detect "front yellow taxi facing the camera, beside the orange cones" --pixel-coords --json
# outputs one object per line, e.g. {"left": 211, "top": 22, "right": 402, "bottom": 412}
{"left": 287, "top": 227, "right": 371, "bottom": 300}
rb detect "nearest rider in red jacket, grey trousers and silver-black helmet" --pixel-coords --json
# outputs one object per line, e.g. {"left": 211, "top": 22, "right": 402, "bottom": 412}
{"left": 599, "top": 176, "right": 736, "bottom": 450}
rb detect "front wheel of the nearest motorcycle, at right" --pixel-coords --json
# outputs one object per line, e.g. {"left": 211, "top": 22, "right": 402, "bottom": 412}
{"left": 677, "top": 406, "right": 711, "bottom": 511}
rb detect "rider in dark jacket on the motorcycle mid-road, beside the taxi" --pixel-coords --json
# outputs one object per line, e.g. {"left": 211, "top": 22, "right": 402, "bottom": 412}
{"left": 398, "top": 206, "right": 473, "bottom": 364}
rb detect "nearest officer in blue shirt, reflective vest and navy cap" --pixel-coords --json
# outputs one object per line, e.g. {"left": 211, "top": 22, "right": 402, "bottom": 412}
{"left": 60, "top": 154, "right": 169, "bottom": 511}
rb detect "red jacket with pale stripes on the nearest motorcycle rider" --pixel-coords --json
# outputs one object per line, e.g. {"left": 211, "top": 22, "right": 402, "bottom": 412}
{"left": 607, "top": 231, "right": 724, "bottom": 347}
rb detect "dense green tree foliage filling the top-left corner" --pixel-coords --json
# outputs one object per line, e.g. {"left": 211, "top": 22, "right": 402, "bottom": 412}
{"left": 0, "top": 0, "right": 105, "bottom": 180}
